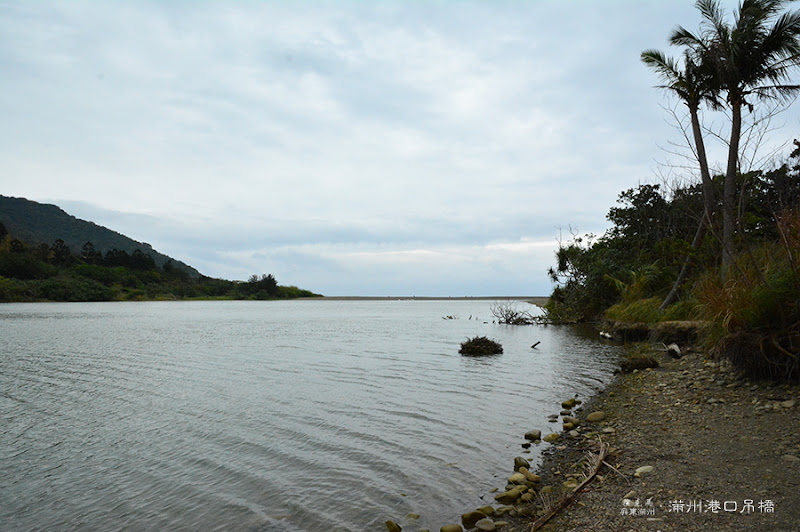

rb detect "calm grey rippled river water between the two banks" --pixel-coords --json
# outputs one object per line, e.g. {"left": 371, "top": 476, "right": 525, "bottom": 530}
{"left": 0, "top": 301, "right": 616, "bottom": 531}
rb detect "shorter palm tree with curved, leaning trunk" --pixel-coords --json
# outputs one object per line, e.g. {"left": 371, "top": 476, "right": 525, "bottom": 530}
{"left": 641, "top": 50, "right": 720, "bottom": 310}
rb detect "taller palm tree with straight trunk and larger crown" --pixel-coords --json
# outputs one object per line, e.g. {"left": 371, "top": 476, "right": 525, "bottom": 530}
{"left": 670, "top": 0, "right": 800, "bottom": 267}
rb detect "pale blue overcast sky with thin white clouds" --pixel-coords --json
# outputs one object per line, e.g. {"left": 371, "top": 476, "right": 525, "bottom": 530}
{"left": 0, "top": 0, "right": 800, "bottom": 296}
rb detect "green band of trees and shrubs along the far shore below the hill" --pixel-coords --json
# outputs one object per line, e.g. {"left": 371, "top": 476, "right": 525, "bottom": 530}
{"left": 0, "top": 222, "right": 317, "bottom": 302}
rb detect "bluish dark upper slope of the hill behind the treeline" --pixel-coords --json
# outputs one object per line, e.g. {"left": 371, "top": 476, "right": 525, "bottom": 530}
{"left": 0, "top": 195, "right": 200, "bottom": 278}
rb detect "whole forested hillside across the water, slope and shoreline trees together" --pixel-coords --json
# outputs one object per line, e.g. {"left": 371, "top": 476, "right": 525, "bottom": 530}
{"left": 0, "top": 196, "right": 316, "bottom": 302}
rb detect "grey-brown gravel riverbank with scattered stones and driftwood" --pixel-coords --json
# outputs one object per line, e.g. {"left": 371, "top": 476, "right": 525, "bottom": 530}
{"left": 494, "top": 342, "right": 800, "bottom": 532}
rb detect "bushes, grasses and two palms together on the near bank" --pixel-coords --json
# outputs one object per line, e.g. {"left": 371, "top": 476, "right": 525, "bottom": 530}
{"left": 546, "top": 0, "right": 800, "bottom": 379}
